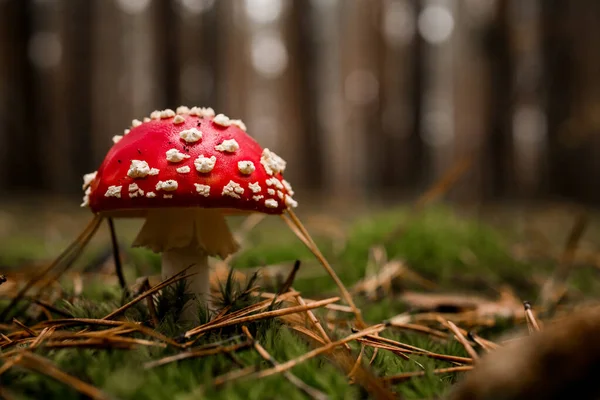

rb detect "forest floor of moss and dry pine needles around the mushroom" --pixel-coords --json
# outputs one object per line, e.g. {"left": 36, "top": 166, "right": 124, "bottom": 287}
{"left": 0, "top": 198, "right": 600, "bottom": 399}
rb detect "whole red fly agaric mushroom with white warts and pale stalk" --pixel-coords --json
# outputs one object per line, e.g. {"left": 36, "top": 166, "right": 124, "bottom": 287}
{"left": 82, "top": 106, "right": 297, "bottom": 321}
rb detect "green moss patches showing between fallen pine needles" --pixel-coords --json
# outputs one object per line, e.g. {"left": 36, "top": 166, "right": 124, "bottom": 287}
{"left": 0, "top": 207, "right": 600, "bottom": 399}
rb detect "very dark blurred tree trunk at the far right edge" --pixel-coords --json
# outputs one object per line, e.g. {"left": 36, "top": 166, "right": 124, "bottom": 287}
{"left": 543, "top": 0, "right": 600, "bottom": 201}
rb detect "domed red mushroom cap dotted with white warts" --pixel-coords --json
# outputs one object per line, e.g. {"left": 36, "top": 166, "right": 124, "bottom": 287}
{"left": 82, "top": 107, "right": 296, "bottom": 215}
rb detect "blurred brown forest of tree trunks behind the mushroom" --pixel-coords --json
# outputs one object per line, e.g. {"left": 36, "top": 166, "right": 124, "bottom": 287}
{"left": 0, "top": 0, "right": 600, "bottom": 208}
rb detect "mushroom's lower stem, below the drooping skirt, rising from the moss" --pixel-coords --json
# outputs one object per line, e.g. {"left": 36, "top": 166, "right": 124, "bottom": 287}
{"left": 161, "top": 244, "right": 211, "bottom": 322}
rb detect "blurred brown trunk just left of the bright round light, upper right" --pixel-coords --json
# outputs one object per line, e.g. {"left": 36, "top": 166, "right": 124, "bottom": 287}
{"left": 380, "top": 0, "right": 423, "bottom": 193}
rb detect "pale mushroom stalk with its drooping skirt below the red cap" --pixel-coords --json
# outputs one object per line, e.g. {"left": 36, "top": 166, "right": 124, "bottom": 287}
{"left": 133, "top": 208, "right": 239, "bottom": 322}
